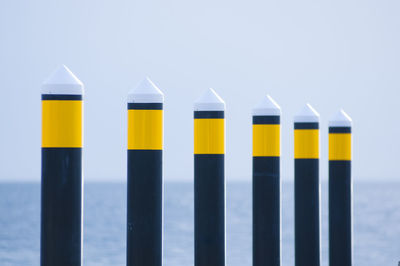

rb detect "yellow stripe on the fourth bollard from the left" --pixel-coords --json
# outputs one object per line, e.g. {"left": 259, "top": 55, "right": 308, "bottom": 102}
{"left": 253, "top": 125, "right": 280, "bottom": 157}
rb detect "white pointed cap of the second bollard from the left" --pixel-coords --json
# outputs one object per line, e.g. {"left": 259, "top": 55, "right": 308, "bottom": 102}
{"left": 128, "top": 77, "right": 164, "bottom": 103}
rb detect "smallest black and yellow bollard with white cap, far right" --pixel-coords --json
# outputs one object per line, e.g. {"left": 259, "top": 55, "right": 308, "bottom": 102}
{"left": 329, "top": 110, "right": 353, "bottom": 266}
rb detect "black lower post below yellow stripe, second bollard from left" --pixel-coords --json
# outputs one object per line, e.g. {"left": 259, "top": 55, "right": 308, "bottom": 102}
{"left": 126, "top": 150, "right": 163, "bottom": 266}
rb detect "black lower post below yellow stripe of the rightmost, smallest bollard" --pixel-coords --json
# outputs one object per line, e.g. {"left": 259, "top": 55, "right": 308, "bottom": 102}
{"left": 329, "top": 161, "right": 352, "bottom": 266}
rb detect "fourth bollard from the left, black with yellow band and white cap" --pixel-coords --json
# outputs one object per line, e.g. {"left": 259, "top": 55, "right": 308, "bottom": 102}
{"left": 253, "top": 96, "right": 281, "bottom": 266}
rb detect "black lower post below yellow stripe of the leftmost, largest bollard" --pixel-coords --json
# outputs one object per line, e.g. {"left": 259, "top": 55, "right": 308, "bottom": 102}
{"left": 40, "top": 148, "right": 82, "bottom": 266}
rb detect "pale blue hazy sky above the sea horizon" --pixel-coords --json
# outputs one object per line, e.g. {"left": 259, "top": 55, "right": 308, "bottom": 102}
{"left": 0, "top": 0, "right": 400, "bottom": 182}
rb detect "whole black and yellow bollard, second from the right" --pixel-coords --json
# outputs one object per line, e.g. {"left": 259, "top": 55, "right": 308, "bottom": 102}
{"left": 294, "top": 104, "right": 320, "bottom": 266}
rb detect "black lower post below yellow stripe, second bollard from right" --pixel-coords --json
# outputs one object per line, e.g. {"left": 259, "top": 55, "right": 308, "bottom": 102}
{"left": 294, "top": 159, "right": 320, "bottom": 266}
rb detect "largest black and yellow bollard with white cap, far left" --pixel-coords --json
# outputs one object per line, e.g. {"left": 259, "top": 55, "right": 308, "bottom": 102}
{"left": 40, "top": 66, "right": 83, "bottom": 266}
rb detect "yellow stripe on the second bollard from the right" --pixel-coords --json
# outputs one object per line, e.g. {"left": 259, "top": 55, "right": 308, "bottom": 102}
{"left": 294, "top": 129, "right": 319, "bottom": 159}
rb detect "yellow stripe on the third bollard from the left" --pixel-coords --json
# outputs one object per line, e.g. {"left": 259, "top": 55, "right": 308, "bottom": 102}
{"left": 194, "top": 118, "right": 225, "bottom": 154}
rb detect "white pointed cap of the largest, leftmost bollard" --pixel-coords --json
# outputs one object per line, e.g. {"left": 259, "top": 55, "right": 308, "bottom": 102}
{"left": 42, "top": 65, "right": 83, "bottom": 95}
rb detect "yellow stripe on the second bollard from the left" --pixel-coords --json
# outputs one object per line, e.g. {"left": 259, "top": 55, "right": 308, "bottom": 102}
{"left": 128, "top": 110, "right": 163, "bottom": 150}
